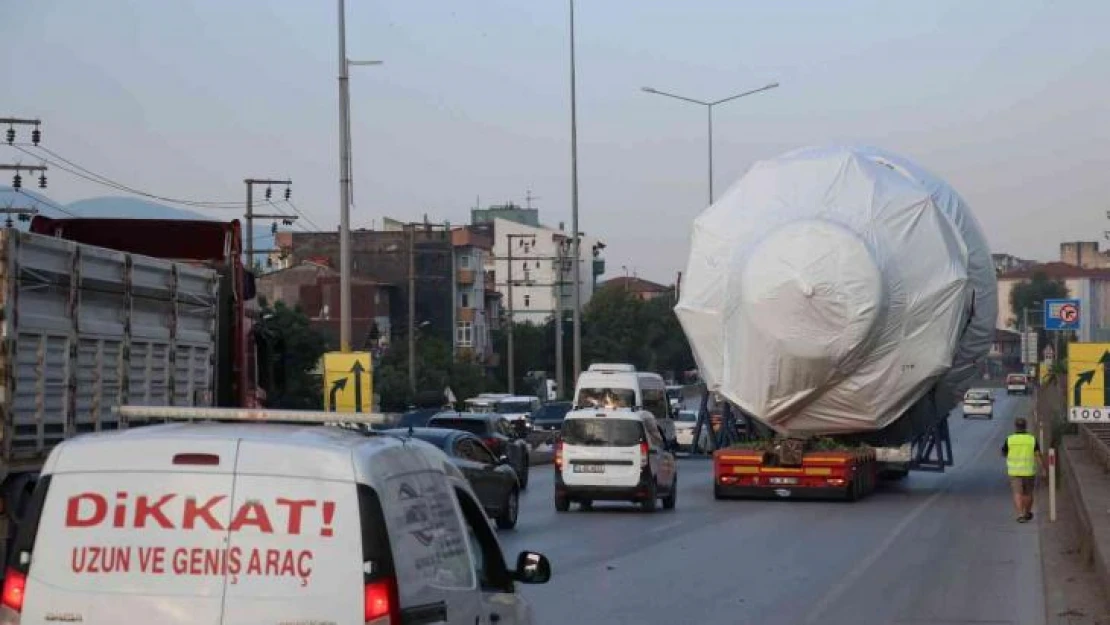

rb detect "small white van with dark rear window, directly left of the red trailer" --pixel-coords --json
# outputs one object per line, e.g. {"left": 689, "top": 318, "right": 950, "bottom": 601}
{"left": 555, "top": 410, "right": 678, "bottom": 512}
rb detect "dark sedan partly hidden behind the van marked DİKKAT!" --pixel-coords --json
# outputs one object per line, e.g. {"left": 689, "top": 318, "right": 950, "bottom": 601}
{"left": 385, "top": 427, "right": 521, "bottom": 530}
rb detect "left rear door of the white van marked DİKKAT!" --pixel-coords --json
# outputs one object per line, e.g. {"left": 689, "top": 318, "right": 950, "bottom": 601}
{"left": 12, "top": 438, "right": 236, "bottom": 625}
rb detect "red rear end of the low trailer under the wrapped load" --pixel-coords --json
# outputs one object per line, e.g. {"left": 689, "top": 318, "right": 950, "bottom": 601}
{"left": 713, "top": 448, "right": 878, "bottom": 501}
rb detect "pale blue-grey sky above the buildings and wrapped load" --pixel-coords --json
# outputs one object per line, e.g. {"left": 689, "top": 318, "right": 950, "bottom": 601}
{"left": 0, "top": 0, "right": 1110, "bottom": 282}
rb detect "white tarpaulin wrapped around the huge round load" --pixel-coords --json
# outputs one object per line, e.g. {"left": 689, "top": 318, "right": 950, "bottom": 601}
{"left": 675, "top": 147, "right": 998, "bottom": 434}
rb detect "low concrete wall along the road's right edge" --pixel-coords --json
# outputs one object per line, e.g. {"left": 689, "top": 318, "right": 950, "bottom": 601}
{"left": 1058, "top": 435, "right": 1110, "bottom": 596}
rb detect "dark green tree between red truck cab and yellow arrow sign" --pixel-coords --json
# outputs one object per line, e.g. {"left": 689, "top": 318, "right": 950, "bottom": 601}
{"left": 258, "top": 302, "right": 326, "bottom": 410}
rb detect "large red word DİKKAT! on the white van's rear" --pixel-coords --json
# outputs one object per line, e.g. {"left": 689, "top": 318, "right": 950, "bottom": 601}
{"left": 65, "top": 492, "right": 335, "bottom": 536}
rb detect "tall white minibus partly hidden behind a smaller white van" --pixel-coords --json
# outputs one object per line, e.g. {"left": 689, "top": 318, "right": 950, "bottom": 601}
{"left": 574, "top": 363, "right": 677, "bottom": 450}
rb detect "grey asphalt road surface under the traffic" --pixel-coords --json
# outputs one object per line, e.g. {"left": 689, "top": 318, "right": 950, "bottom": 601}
{"left": 501, "top": 394, "right": 1045, "bottom": 625}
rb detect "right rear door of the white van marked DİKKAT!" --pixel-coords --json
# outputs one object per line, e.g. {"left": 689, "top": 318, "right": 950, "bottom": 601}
{"left": 223, "top": 440, "right": 364, "bottom": 623}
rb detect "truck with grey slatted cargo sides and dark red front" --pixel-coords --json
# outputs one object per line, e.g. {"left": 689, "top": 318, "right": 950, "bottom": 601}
{"left": 0, "top": 216, "right": 266, "bottom": 561}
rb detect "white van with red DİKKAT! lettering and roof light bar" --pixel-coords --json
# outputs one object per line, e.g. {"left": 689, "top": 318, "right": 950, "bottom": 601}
{"left": 0, "top": 409, "right": 551, "bottom": 625}
